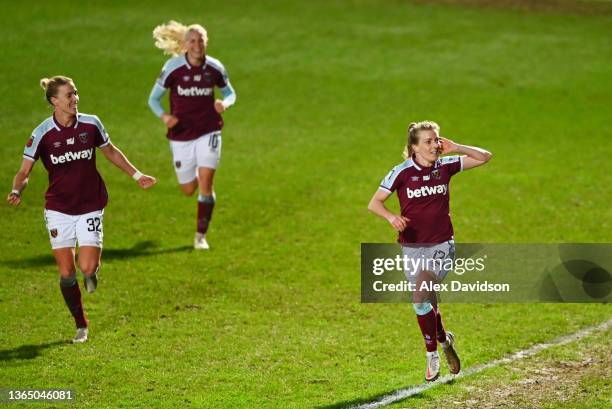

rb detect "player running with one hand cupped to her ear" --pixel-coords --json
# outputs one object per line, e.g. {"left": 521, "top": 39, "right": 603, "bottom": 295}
{"left": 368, "top": 121, "right": 491, "bottom": 382}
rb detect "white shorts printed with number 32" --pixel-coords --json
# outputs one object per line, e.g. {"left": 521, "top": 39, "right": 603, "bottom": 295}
{"left": 45, "top": 209, "right": 104, "bottom": 249}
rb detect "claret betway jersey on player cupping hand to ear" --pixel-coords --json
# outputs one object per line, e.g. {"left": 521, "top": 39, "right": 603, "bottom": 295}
{"left": 380, "top": 156, "right": 463, "bottom": 244}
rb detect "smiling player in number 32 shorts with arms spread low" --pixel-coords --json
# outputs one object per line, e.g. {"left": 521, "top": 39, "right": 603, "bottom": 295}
{"left": 7, "top": 75, "right": 156, "bottom": 343}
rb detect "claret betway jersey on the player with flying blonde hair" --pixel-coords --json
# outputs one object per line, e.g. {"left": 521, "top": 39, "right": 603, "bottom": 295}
{"left": 157, "top": 55, "right": 229, "bottom": 141}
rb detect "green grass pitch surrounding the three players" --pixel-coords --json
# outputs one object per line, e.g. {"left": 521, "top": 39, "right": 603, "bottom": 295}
{"left": 0, "top": 0, "right": 612, "bottom": 408}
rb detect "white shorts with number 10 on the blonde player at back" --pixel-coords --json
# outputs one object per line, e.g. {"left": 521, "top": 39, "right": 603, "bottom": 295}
{"left": 170, "top": 131, "right": 221, "bottom": 184}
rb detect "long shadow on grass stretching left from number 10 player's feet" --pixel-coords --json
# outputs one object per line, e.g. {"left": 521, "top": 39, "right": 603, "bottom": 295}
{"left": 0, "top": 240, "right": 193, "bottom": 269}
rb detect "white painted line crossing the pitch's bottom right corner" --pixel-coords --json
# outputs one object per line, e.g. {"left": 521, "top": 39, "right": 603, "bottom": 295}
{"left": 350, "top": 319, "right": 612, "bottom": 409}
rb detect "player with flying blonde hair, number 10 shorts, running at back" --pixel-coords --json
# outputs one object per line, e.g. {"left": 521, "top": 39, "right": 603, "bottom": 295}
{"left": 149, "top": 21, "right": 236, "bottom": 250}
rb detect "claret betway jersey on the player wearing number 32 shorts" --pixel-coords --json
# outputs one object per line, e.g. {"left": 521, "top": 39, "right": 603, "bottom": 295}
{"left": 23, "top": 113, "right": 110, "bottom": 215}
